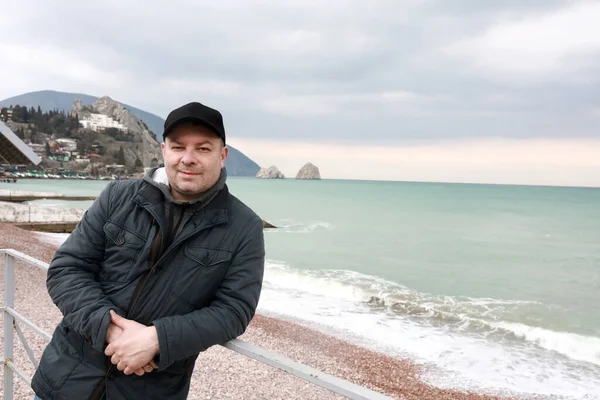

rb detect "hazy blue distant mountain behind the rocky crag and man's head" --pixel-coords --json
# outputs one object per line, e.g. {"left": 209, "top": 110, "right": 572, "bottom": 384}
{"left": 0, "top": 90, "right": 260, "bottom": 176}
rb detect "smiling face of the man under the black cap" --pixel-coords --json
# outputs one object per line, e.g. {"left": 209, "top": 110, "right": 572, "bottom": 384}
{"left": 162, "top": 123, "right": 229, "bottom": 201}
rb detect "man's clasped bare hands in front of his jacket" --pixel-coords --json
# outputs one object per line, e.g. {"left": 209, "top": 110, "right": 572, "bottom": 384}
{"left": 104, "top": 310, "right": 159, "bottom": 376}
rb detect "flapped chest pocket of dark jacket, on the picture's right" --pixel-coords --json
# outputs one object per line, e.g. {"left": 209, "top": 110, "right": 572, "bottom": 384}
{"left": 171, "top": 246, "right": 232, "bottom": 308}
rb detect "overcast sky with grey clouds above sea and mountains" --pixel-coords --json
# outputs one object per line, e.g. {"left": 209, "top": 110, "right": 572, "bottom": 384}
{"left": 0, "top": 0, "right": 600, "bottom": 186}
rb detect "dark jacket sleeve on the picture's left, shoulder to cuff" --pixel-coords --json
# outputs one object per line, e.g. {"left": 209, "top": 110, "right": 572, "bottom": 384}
{"left": 46, "top": 182, "right": 119, "bottom": 351}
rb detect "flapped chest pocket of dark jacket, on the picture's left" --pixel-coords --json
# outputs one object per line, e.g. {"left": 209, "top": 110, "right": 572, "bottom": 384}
{"left": 100, "top": 221, "right": 147, "bottom": 282}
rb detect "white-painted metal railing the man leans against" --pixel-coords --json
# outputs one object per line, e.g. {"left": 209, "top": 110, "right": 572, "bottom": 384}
{"left": 0, "top": 249, "right": 391, "bottom": 400}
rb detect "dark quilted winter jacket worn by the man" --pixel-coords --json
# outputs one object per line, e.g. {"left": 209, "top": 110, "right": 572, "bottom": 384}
{"left": 32, "top": 170, "right": 265, "bottom": 400}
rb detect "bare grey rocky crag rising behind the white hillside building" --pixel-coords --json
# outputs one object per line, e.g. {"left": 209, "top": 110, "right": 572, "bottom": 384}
{"left": 71, "top": 96, "right": 162, "bottom": 167}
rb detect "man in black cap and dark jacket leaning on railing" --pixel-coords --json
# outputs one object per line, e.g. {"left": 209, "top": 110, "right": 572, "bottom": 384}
{"left": 32, "top": 103, "right": 265, "bottom": 400}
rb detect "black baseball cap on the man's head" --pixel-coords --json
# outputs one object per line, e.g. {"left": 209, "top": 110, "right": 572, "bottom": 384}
{"left": 163, "top": 102, "right": 225, "bottom": 143}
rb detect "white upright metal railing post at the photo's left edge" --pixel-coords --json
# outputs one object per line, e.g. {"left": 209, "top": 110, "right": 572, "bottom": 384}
{"left": 3, "top": 254, "right": 15, "bottom": 400}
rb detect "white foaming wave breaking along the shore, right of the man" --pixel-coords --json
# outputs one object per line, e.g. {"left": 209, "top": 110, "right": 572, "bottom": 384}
{"left": 265, "top": 261, "right": 600, "bottom": 366}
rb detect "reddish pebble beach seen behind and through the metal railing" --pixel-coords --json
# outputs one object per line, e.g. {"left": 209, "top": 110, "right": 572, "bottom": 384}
{"left": 0, "top": 223, "right": 524, "bottom": 400}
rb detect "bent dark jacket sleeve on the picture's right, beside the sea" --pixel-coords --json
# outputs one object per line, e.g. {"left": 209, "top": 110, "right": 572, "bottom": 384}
{"left": 152, "top": 218, "right": 265, "bottom": 371}
